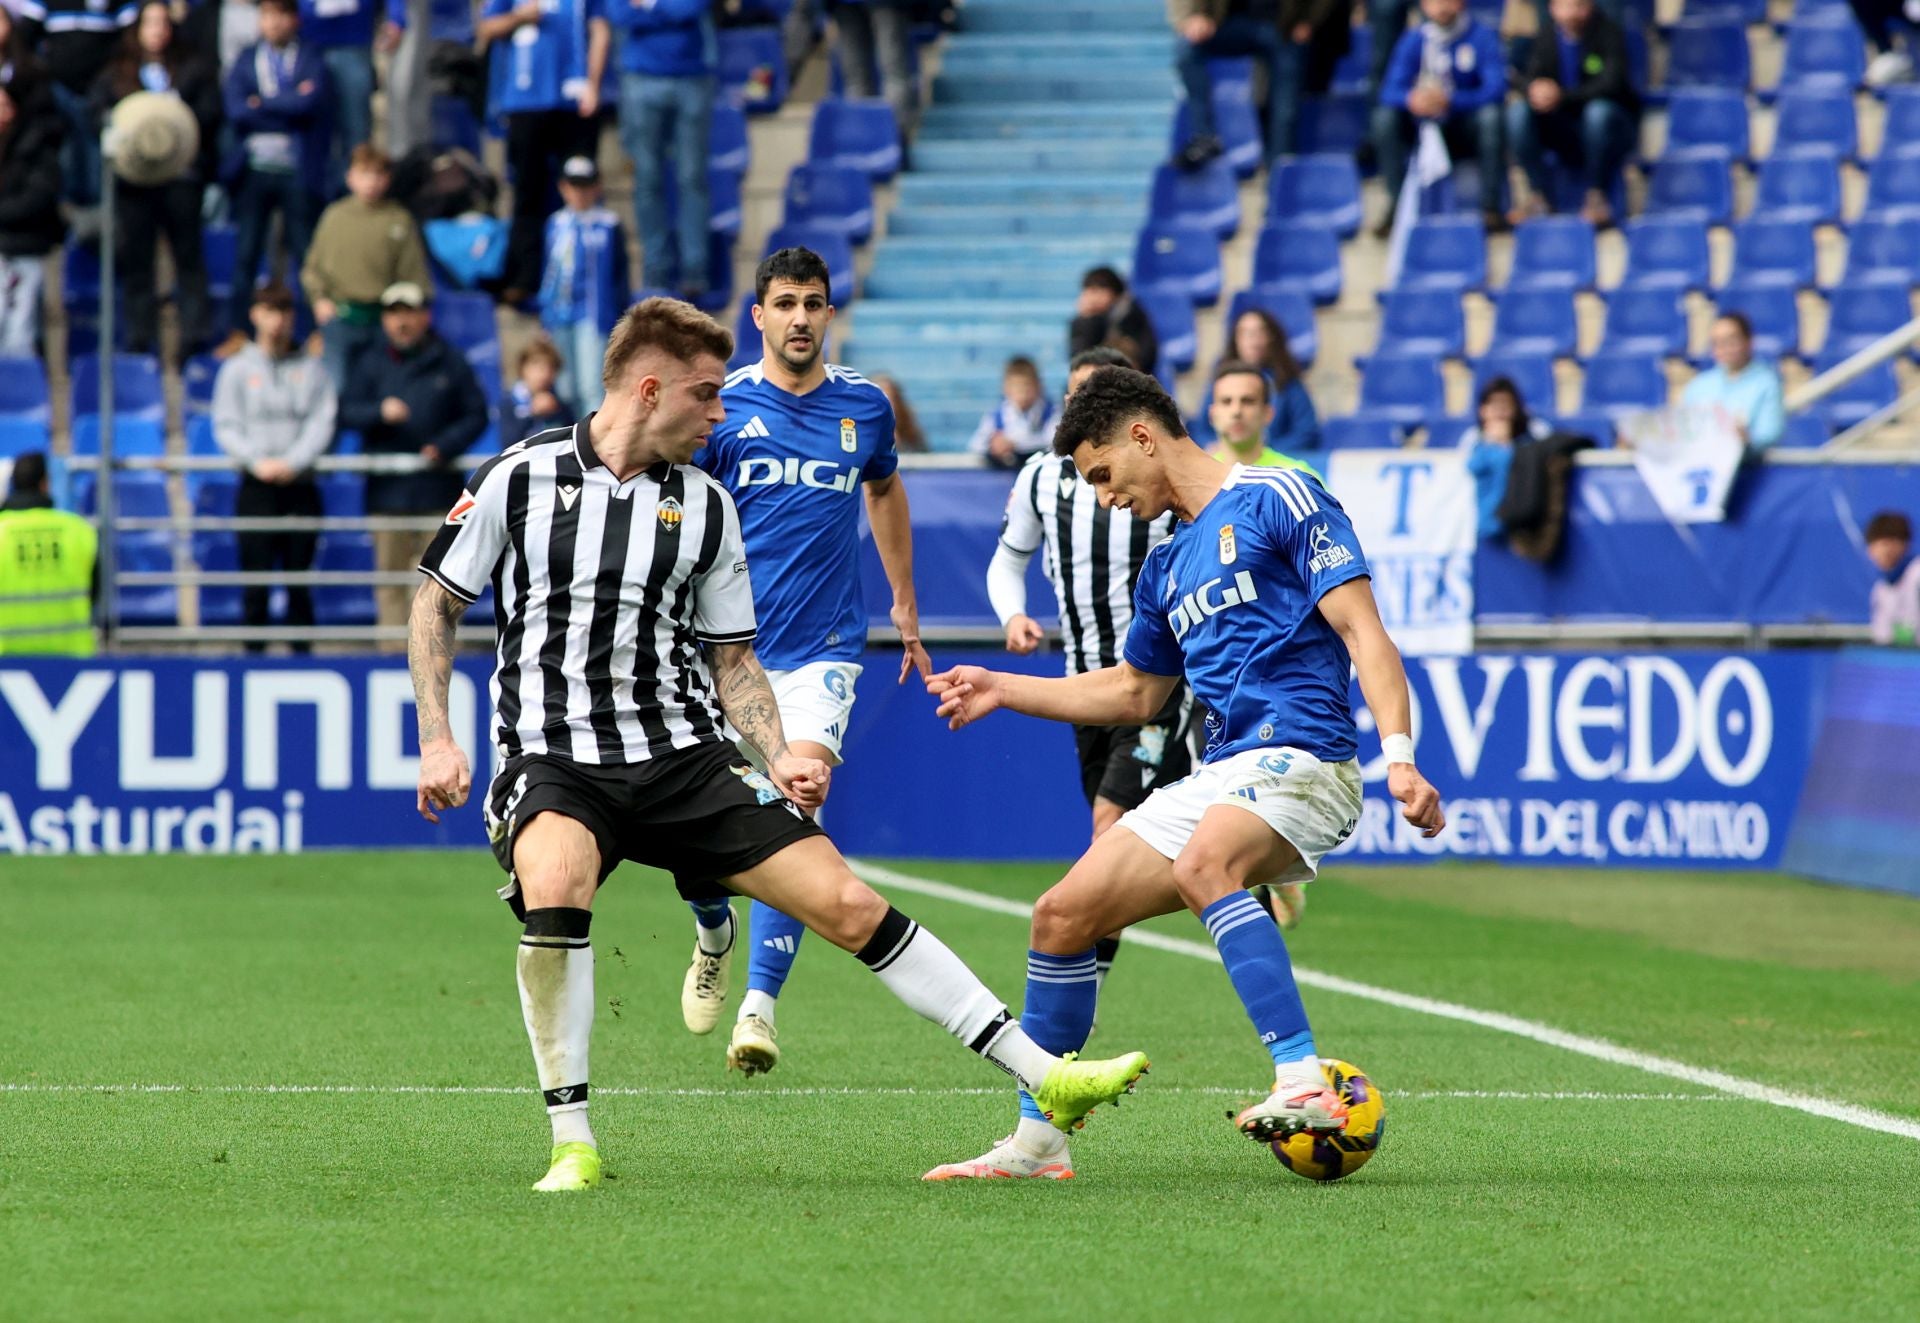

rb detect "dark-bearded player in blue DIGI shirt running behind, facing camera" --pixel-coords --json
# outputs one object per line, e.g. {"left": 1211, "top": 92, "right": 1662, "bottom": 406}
{"left": 680, "top": 248, "right": 933, "bottom": 1075}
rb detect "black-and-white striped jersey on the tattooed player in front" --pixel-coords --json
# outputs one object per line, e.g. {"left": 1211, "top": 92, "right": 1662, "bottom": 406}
{"left": 420, "top": 419, "right": 755, "bottom": 764}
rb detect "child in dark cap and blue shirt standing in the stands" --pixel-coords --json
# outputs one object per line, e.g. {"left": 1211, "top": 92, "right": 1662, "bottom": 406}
{"left": 540, "top": 156, "right": 634, "bottom": 415}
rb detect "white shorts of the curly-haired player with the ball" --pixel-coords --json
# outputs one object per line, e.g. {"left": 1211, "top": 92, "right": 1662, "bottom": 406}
{"left": 1119, "top": 747, "right": 1359, "bottom": 883}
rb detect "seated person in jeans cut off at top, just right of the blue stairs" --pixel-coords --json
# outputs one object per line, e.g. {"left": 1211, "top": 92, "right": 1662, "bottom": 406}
{"left": 1167, "top": 0, "right": 1352, "bottom": 169}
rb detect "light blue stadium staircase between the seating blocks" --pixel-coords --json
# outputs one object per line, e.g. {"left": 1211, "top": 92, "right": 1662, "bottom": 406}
{"left": 839, "top": 0, "right": 1179, "bottom": 449}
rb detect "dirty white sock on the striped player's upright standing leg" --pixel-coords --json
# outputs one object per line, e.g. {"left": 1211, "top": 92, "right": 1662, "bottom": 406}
{"left": 516, "top": 908, "right": 593, "bottom": 1144}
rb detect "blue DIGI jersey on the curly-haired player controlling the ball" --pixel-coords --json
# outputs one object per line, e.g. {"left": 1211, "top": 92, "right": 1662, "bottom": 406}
{"left": 1125, "top": 465, "right": 1367, "bottom": 762}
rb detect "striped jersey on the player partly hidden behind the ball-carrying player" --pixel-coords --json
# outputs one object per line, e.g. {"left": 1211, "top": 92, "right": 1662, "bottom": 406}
{"left": 995, "top": 453, "right": 1173, "bottom": 676}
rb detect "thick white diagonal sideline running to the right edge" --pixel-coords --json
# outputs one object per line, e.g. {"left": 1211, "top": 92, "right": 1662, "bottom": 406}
{"left": 849, "top": 860, "right": 1920, "bottom": 1141}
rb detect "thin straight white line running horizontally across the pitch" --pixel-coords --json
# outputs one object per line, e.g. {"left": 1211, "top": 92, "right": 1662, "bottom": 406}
{"left": 0, "top": 1083, "right": 1741, "bottom": 1102}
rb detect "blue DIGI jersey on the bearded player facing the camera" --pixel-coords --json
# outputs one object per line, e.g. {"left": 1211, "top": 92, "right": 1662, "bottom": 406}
{"left": 693, "top": 363, "right": 900, "bottom": 670}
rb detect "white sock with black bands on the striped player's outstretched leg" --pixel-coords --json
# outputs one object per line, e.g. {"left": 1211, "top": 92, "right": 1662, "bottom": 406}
{"left": 858, "top": 906, "right": 1060, "bottom": 1093}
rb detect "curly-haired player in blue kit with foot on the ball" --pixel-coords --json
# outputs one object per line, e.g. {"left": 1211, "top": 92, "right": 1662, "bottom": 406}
{"left": 927, "top": 367, "right": 1446, "bottom": 1181}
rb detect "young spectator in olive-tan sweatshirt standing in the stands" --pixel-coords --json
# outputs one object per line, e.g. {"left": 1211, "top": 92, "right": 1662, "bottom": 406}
{"left": 300, "top": 144, "right": 430, "bottom": 390}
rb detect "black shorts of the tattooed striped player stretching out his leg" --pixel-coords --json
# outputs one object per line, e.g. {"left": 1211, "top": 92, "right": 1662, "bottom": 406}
{"left": 486, "top": 741, "right": 822, "bottom": 916}
